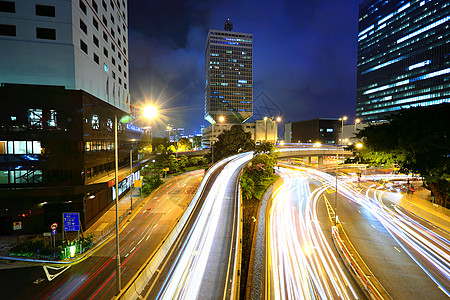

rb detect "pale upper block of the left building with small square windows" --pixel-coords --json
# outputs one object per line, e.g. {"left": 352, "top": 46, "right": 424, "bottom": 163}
{"left": 0, "top": 0, "right": 130, "bottom": 111}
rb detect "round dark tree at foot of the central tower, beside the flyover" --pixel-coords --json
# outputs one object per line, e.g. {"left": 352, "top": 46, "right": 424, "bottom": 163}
{"left": 213, "top": 125, "right": 255, "bottom": 161}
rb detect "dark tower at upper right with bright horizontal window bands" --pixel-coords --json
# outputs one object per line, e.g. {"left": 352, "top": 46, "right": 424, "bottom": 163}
{"left": 356, "top": 0, "right": 450, "bottom": 123}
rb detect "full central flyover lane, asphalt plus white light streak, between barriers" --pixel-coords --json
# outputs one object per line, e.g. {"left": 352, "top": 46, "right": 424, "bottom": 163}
{"left": 141, "top": 153, "right": 252, "bottom": 299}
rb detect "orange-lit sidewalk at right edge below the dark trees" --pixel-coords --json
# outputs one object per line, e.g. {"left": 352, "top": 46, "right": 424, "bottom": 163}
{"left": 389, "top": 182, "right": 450, "bottom": 232}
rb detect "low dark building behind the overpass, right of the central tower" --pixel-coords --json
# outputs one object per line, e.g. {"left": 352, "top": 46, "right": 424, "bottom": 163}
{"left": 284, "top": 119, "right": 341, "bottom": 144}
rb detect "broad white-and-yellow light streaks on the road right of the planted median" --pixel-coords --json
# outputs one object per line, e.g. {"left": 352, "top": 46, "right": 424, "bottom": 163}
{"left": 266, "top": 168, "right": 358, "bottom": 299}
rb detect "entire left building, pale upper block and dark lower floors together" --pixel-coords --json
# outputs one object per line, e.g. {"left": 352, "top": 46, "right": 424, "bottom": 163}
{"left": 0, "top": 0, "right": 135, "bottom": 233}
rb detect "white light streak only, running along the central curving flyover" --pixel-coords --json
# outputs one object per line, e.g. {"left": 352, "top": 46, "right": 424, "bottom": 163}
{"left": 157, "top": 153, "right": 252, "bottom": 299}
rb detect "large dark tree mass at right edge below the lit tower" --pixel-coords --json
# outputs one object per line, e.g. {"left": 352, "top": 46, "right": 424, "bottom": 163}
{"left": 356, "top": 103, "right": 450, "bottom": 207}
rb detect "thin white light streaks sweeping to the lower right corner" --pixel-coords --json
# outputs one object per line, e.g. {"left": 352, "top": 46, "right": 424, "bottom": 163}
{"left": 288, "top": 167, "right": 450, "bottom": 297}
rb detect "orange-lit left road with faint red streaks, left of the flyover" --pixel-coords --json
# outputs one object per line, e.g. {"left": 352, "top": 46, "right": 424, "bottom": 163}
{"left": 0, "top": 170, "right": 204, "bottom": 299}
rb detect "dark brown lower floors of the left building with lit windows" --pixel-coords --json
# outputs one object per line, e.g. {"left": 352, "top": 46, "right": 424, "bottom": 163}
{"left": 0, "top": 85, "right": 141, "bottom": 233}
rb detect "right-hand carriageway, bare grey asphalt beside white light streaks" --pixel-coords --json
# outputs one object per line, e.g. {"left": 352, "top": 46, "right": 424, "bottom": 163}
{"left": 294, "top": 168, "right": 449, "bottom": 299}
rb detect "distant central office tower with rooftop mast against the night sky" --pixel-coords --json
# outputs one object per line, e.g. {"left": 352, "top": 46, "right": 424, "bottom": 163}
{"left": 205, "top": 19, "right": 253, "bottom": 124}
